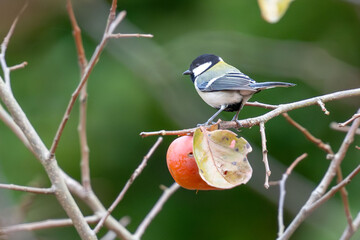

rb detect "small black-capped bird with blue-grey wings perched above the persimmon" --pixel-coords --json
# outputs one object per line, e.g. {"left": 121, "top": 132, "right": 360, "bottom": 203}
{"left": 183, "top": 54, "right": 295, "bottom": 126}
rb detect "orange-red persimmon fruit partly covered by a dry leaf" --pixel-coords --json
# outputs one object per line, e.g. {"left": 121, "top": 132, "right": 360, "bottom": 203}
{"left": 166, "top": 136, "right": 218, "bottom": 190}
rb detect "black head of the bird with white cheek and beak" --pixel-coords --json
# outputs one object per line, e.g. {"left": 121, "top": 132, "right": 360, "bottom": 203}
{"left": 183, "top": 54, "right": 222, "bottom": 81}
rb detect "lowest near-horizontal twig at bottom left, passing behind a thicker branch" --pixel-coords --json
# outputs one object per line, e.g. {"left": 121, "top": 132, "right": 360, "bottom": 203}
{"left": 0, "top": 216, "right": 100, "bottom": 236}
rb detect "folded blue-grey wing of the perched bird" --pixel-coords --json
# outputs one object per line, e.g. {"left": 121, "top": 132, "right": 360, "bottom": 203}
{"left": 198, "top": 72, "right": 256, "bottom": 92}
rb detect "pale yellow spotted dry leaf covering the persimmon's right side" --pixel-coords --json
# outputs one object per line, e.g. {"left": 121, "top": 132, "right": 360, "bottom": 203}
{"left": 193, "top": 128, "right": 252, "bottom": 189}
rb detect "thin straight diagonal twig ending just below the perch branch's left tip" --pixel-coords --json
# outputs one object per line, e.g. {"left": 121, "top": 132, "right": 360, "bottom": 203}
{"left": 94, "top": 137, "right": 163, "bottom": 233}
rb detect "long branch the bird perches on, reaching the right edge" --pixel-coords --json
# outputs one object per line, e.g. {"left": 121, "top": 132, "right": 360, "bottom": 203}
{"left": 140, "top": 88, "right": 360, "bottom": 137}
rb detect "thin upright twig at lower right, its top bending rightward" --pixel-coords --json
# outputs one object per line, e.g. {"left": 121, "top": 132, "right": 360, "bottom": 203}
{"left": 278, "top": 153, "right": 307, "bottom": 237}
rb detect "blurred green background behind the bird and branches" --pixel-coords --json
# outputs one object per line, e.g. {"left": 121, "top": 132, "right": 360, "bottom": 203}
{"left": 0, "top": 0, "right": 360, "bottom": 240}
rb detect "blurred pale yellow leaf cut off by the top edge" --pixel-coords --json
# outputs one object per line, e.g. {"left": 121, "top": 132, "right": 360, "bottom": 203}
{"left": 258, "top": 0, "right": 293, "bottom": 23}
